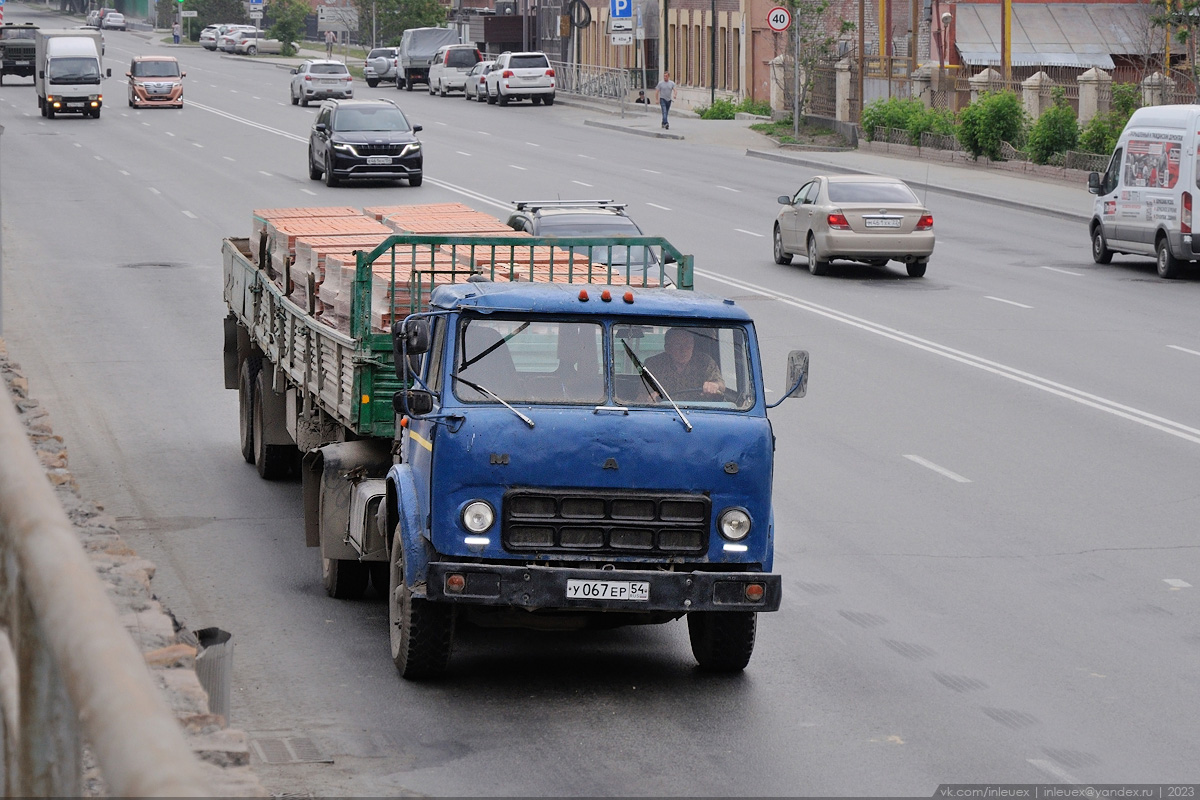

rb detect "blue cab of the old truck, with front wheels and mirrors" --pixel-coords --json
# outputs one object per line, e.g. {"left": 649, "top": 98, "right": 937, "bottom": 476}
{"left": 382, "top": 282, "right": 806, "bottom": 678}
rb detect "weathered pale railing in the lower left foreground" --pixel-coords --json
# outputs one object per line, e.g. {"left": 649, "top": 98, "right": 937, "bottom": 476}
{"left": 0, "top": 384, "right": 209, "bottom": 798}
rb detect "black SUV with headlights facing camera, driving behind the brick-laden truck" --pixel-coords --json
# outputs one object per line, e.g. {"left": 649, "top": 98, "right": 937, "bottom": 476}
{"left": 308, "top": 100, "right": 424, "bottom": 186}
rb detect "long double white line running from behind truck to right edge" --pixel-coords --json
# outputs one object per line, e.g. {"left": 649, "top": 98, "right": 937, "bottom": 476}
{"left": 694, "top": 270, "right": 1200, "bottom": 445}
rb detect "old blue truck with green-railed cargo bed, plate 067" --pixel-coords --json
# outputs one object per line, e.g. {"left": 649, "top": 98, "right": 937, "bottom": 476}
{"left": 224, "top": 215, "right": 808, "bottom": 680}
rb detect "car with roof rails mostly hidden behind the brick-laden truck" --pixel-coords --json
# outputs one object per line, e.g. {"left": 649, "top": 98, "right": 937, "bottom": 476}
{"left": 505, "top": 200, "right": 659, "bottom": 277}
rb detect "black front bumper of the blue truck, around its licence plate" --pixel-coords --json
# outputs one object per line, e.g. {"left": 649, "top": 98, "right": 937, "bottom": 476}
{"left": 426, "top": 561, "right": 782, "bottom": 613}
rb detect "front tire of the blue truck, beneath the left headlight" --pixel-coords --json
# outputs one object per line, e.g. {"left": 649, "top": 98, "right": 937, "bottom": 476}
{"left": 388, "top": 528, "right": 455, "bottom": 680}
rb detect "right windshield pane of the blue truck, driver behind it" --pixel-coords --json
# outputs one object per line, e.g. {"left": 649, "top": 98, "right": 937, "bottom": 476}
{"left": 612, "top": 324, "right": 755, "bottom": 411}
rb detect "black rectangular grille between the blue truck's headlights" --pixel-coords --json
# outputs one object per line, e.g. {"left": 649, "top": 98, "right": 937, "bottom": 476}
{"left": 502, "top": 489, "right": 712, "bottom": 555}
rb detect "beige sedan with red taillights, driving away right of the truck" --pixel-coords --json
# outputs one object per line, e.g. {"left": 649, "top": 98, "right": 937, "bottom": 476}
{"left": 773, "top": 175, "right": 934, "bottom": 278}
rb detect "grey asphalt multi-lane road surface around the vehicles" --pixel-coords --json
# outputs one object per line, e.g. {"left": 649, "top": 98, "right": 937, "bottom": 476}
{"left": 0, "top": 4, "right": 1200, "bottom": 796}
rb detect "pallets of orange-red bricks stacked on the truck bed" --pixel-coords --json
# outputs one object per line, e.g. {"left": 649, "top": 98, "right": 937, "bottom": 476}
{"left": 251, "top": 203, "right": 659, "bottom": 332}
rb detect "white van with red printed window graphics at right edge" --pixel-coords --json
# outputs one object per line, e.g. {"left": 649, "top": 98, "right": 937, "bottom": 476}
{"left": 1087, "top": 106, "right": 1200, "bottom": 278}
